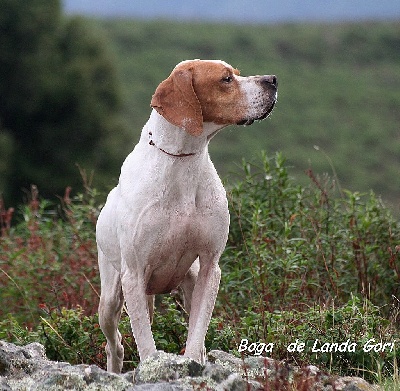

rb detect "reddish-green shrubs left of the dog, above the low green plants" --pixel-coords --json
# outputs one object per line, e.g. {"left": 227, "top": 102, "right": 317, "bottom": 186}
{"left": 0, "top": 186, "right": 99, "bottom": 325}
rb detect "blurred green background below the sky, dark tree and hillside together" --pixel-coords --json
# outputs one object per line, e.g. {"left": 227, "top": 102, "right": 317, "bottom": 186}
{"left": 0, "top": 0, "right": 400, "bottom": 210}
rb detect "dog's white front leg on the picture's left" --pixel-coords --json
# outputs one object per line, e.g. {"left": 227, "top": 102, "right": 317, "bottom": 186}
{"left": 122, "top": 270, "right": 156, "bottom": 361}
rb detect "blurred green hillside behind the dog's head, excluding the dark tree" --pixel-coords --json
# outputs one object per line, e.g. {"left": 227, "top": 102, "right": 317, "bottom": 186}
{"left": 93, "top": 20, "right": 400, "bottom": 208}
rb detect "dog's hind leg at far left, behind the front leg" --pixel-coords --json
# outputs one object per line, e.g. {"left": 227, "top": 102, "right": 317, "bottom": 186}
{"left": 98, "top": 248, "right": 124, "bottom": 373}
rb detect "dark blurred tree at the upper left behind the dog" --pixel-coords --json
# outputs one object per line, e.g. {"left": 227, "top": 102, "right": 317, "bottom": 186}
{"left": 0, "top": 0, "right": 122, "bottom": 202}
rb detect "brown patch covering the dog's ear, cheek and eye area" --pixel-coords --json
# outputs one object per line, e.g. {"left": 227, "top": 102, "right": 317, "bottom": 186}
{"left": 151, "top": 60, "right": 247, "bottom": 136}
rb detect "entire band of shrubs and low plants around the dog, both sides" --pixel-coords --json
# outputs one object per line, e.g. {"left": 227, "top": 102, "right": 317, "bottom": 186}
{"left": 0, "top": 154, "right": 400, "bottom": 380}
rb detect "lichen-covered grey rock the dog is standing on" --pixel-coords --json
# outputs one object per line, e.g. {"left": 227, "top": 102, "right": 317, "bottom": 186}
{"left": 0, "top": 341, "right": 379, "bottom": 391}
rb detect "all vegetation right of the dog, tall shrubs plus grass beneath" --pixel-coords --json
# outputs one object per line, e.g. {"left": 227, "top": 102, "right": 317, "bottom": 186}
{"left": 215, "top": 153, "right": 400, "bottom": 380}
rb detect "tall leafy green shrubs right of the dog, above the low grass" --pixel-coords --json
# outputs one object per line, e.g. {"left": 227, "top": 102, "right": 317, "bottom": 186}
{"left": 219, "top": 153, "right": 400, "bottom": 317}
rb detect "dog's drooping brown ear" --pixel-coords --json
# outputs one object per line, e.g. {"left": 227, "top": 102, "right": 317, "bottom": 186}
{"left": 150, "top": 67, "right": 203, "bottom": 136}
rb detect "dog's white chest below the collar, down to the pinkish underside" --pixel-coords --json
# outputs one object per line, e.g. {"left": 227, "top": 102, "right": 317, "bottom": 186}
{"left": 117, "top": 147, "right": 229, "bottom": 294}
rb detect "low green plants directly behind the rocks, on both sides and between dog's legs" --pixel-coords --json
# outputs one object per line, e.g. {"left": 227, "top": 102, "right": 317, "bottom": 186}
{"left": 0, "top": 296, "right": 400, "bottom": 381}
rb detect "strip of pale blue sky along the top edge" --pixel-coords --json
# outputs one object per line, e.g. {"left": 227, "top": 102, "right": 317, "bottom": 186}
{"left": 63, "top": 0, "right": 400, "bottom": 23}
